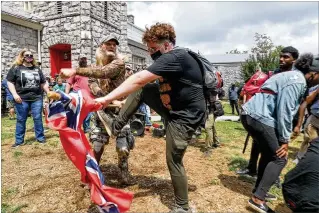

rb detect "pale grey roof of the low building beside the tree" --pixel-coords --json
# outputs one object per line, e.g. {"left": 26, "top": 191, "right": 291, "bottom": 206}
{"left": 205, "top": 54, "right": 249, "bottom": 64}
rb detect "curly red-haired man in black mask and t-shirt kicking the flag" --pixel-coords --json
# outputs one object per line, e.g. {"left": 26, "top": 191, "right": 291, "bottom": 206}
{"left": 96, "top": 23, "right": 206, "bottom": 213}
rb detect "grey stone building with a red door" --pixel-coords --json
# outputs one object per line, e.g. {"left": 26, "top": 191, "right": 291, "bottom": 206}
{"left": 1, "top": 1, "right": 148, "bottom": 76}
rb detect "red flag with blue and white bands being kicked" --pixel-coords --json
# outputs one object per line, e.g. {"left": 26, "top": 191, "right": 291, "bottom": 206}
{"left": 45, "top": 90, "right": 133, "bottom": 213}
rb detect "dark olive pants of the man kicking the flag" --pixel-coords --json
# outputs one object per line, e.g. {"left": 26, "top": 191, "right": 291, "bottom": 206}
{"left": 113, "top": 84, "right": 195, "bottom": 210}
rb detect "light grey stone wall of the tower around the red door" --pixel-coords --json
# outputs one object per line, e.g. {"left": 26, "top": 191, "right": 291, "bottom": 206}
{"left": 30, "top": 1, "right": 130, "bottom": 75}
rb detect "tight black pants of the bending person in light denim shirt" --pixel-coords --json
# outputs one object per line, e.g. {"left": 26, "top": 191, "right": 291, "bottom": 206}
{"left": 241, "top": 115, "right": 287, "bottom": 200}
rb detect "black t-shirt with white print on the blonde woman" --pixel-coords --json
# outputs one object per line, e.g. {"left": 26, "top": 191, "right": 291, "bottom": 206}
{"left": 7, "top": 65, "right": 45, "bottom": 101}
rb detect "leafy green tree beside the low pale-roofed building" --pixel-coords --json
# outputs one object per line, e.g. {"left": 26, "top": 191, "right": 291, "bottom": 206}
{"left": 241, "top": 33, "right": 283, "bottom": 80}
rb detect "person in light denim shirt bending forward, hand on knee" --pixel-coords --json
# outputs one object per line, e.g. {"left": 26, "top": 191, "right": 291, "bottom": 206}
{"left": 241, "top": 52, "right": 319, "bottom": 213}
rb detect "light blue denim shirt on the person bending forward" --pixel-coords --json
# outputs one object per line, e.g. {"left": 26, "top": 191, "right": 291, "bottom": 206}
{"left": 243, "top": 70, "right": 307, "bottom": 143}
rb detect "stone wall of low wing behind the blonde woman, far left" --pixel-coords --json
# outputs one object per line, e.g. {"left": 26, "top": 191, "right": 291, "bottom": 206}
{"left": 1, "top": 21, "right": 38, "bottom": 75}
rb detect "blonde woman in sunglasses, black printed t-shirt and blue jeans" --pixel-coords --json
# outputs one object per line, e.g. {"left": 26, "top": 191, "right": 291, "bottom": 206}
{"left": 7, "top": 50, "right": 49, "bottom": 147}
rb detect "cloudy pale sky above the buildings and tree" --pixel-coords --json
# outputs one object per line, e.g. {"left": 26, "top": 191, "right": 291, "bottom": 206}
{"left": 128, "top": 2, "right": 319, "bottom": 55}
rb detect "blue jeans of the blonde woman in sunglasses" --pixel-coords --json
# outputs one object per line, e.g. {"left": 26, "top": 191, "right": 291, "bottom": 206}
{"left": 15, "top": 98, "right": 45, "bottom": 145}
